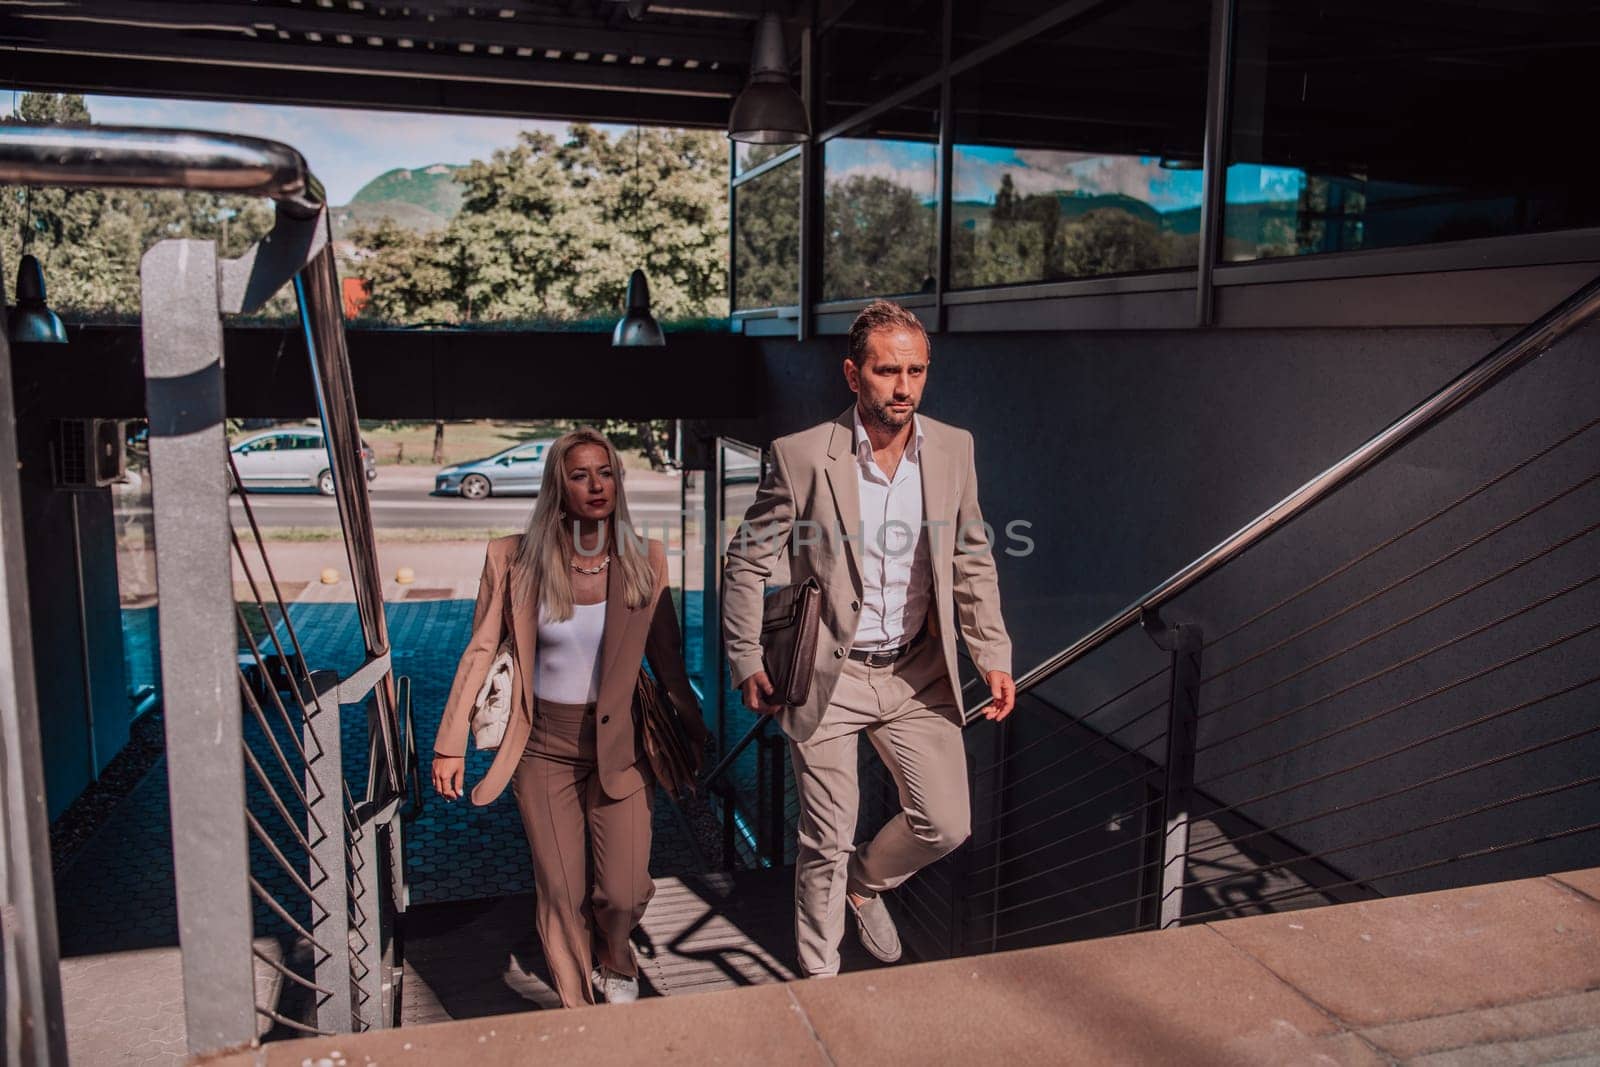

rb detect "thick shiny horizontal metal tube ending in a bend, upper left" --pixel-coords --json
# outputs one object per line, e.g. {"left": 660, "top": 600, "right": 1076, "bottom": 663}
{"left": 0, "top": 123, "right": 328, "bottom": 218}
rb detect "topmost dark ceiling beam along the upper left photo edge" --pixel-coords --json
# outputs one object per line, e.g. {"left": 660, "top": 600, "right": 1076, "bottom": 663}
{"left": 0, "top": 0, "right": 750, "bottom": 67}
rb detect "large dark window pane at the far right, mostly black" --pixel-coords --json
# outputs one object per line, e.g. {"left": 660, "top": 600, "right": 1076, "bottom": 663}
{"left": 1222, "top": 0, "right": 1600, "bottom": 261}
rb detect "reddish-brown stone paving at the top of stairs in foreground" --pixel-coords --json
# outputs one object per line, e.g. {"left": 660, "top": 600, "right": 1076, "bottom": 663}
{"left": 206, "top": 869, "right": 1600, "bottom": 1067}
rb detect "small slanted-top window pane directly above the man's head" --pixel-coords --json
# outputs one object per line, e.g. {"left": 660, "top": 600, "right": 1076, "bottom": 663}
{"left": 822, "top": 94, "right": 939, "bottom": 301}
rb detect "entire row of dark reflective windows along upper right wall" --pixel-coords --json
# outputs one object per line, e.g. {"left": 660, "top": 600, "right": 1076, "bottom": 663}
{"left": 734, "top": 0, "right": 1600, "bottom": 321}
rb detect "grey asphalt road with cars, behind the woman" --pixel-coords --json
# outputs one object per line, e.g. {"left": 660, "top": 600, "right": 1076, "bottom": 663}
{"left": 229, "top": 467, "right": 680, "bottom": 536}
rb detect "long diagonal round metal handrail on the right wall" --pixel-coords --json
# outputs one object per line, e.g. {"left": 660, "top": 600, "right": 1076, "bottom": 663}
{"left": 966, "top": 268, "right": 1600, "bottom": 723}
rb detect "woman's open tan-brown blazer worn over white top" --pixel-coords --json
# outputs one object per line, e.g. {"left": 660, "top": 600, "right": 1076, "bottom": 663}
{"left": 434, "top": 534, "right": 706, "bottom": 805}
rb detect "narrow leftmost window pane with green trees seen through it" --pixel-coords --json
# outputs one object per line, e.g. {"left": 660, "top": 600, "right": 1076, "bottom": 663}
{"left": 733, "top": 157, "right": 800, "bottom": 310}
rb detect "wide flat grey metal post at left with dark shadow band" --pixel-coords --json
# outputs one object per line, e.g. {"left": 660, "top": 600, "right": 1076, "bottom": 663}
{"left": 139, "top": 240, "right": 256, "bottom": 1056}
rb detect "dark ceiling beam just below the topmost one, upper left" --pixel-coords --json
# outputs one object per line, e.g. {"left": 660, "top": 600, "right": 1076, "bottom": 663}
{"left": 0, "top": 18, "right": 742, "bottom": 102}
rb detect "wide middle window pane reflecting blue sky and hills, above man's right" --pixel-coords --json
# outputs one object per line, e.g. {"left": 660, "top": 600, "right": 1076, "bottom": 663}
{"left": 950, "top": 0, "right": 1210, "bottom": 288}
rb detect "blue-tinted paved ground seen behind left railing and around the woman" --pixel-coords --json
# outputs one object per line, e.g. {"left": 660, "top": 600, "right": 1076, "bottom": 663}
{"left": 56, "top": 600, "right": 701, "bottom": 955}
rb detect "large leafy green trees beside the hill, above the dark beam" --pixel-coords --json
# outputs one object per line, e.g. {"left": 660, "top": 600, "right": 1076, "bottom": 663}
{"left": 352, "top": 125, "right": 728, "bottom": 323}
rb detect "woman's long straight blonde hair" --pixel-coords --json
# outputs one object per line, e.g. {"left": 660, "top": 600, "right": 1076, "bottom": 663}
{"left": 514, "top": 426, "right": 656, "bottom": 622}
